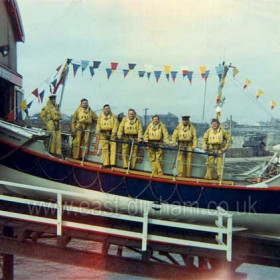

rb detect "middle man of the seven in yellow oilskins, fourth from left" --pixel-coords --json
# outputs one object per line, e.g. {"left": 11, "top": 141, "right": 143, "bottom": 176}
{"left": 118, "top": 109, "right": 143, "bottom": 169}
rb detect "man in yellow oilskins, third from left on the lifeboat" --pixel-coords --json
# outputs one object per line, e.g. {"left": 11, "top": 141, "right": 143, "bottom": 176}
{"left": 96, "top": 104, "right": 119, "bottom": 167}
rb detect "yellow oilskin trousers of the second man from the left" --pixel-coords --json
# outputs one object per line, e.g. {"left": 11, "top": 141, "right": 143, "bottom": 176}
{"left": 72, "top": 123, "right": 91, "bottom": 159}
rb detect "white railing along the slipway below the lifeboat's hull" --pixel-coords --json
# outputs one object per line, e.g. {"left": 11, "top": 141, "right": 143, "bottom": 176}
{"left": 0, "top": 181, "right": 232, "bottom": 261}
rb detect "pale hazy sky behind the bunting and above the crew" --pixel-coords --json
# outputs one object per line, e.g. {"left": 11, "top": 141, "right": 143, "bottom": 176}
{"left": 18, "top": 0, "right": 280, "bottom": 124}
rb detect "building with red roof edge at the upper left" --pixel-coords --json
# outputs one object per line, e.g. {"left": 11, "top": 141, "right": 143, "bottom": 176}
{"left": 0, "top": 0, "right": 24, "bottom": 121}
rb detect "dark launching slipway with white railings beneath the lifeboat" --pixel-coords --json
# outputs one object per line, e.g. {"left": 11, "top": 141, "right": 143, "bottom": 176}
{"left": 0, "top": 181, "right": 280, "bottom": 280}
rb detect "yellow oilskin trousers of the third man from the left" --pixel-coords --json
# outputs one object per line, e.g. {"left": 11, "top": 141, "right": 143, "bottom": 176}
{"left": 100, "top": 130, "right": 117, "bottom": 166}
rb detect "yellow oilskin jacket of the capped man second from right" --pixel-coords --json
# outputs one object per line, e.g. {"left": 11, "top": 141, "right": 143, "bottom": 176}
{"left": 172, "top": 122, "right": 197, "bottom": 148}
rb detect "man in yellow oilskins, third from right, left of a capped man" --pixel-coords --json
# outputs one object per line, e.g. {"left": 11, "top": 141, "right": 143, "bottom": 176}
{"left": 144, "top": 115, "right": 169, "bottom": 175}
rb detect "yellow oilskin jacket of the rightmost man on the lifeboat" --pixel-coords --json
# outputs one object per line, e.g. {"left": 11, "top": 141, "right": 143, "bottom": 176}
{"left": 202, "top": 126, "right": 230, "bottom": 150}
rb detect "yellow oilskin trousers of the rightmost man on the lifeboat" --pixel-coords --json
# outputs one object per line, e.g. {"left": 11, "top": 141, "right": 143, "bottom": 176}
{"left": 204, "top": 144, "right": 223, "bottom": 180}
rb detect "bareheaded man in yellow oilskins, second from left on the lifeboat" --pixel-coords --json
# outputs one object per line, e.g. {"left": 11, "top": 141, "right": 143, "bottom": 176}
{"left": 71, "top": 98, "right": 97, "bottom": 159}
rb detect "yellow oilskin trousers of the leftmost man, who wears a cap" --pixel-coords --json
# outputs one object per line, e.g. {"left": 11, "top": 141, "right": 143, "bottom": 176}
{"left": 46, "top": 120, "right": 61, "bottom": 155}
